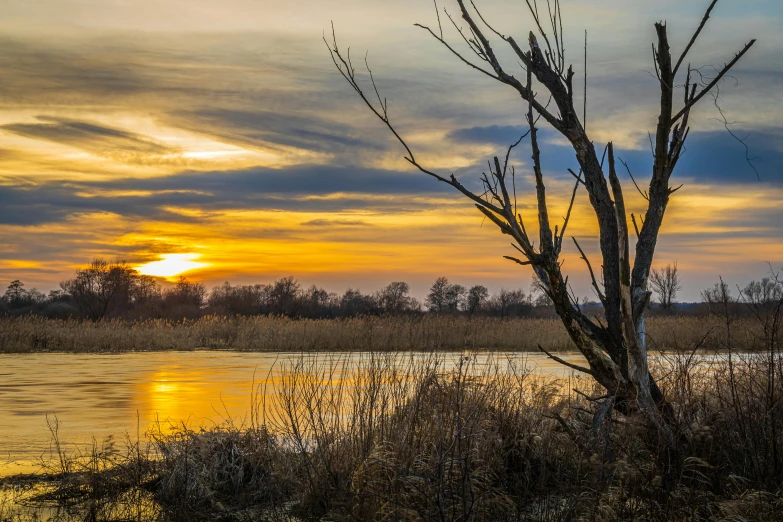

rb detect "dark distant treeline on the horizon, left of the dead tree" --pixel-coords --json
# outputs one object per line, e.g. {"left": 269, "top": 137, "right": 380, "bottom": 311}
{"left": 0, "top": 259, "right": 552, "bottom": 321}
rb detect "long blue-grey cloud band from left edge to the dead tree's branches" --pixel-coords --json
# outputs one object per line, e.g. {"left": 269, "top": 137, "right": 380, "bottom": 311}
{"left": 0, "top": 162, "right": 451, "bottom": 226}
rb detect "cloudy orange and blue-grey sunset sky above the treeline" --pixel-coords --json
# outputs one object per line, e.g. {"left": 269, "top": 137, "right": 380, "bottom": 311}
{"left": 0, "top": 0, "right": 783, "bottom": 300}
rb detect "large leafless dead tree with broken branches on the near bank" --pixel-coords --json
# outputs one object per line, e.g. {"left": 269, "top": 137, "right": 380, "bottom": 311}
{"left": 324, "top": 0, "right": 755, "bottom": 434}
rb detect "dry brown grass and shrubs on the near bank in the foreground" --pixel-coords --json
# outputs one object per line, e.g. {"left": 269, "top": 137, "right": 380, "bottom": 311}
{"left": 0, "top": 354, "right": 783, "bottom": 522}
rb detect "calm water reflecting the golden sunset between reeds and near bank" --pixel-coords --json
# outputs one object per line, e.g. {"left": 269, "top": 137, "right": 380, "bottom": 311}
{"left": 0, "top": 351, "right": 596, "bottom": 477}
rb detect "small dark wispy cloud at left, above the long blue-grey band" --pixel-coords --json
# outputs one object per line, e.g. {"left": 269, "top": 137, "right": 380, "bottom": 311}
{"left": 0, "top": 116, "right": 179, "bottom": 158}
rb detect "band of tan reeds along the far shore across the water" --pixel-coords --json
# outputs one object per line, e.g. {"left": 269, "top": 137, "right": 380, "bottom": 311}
{"left": 0, "top": 315, "right": 760, "bottom": 353}
